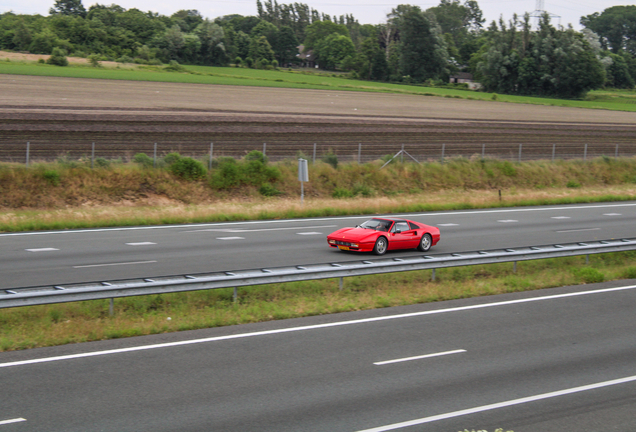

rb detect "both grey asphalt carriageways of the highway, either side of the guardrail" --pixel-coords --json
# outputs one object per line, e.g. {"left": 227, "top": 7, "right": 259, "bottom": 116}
{"left": 0, "top": 202, "right": 636, "bottom": 432}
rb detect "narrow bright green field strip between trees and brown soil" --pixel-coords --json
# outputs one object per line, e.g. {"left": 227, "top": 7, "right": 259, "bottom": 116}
{"left": 0, "top": 61, "right": 636, "bottom": 112}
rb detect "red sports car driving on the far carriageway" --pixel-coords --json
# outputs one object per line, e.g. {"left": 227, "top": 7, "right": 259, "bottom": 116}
{"left": 327, "top": 218, "right": 439, "bottom": 255}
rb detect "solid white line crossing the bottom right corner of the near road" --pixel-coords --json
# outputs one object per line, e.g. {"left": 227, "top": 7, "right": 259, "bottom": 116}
{"left": 358, "top": 376, "right": 636, "bottom": 432}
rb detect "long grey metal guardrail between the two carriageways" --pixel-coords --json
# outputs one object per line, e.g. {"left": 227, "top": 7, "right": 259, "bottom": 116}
{"left": 0, "top": 238, "right": 636, "bottom": 308}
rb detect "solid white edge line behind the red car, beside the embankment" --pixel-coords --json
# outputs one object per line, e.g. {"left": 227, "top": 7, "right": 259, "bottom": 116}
{"left": 0, "top": 203, "right": 636, "bottom": 237}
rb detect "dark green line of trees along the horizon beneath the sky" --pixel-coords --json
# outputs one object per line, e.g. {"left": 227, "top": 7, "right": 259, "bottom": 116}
{"left": 0, "top": 0, "right": 636, "bottom": 98}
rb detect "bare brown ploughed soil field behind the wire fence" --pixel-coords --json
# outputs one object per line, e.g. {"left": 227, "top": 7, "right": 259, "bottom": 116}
{"left": 0, "top": 75, "right": 636, "bottom": 162}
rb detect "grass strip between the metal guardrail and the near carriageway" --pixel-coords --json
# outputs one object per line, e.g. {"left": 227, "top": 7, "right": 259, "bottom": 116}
{"left": 0, "top": 252, "right": 636, "bottom": 351}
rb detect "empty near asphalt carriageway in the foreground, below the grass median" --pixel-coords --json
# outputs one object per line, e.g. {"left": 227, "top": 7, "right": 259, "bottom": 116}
{"left": 0, "top": 281, "right": 636, "bottom": 432}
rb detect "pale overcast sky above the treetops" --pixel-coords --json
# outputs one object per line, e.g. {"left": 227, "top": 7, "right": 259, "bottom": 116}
{"left": 0, "top": 0, "right": 636, "bottom": 30}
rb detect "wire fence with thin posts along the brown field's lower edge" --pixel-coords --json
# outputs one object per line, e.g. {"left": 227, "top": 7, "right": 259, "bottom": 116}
{"left": 0, "top": 141, "right": 636, "bottom": 166}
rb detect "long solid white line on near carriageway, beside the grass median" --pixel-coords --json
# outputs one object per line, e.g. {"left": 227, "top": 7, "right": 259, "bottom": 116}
{"left": 0, "top": 285, "right": 636, "bottom": 368}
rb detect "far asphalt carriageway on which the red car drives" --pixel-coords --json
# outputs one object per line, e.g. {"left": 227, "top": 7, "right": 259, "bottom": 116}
{"left": 0, "top": 202, "right": 636, "bottom": 289}
